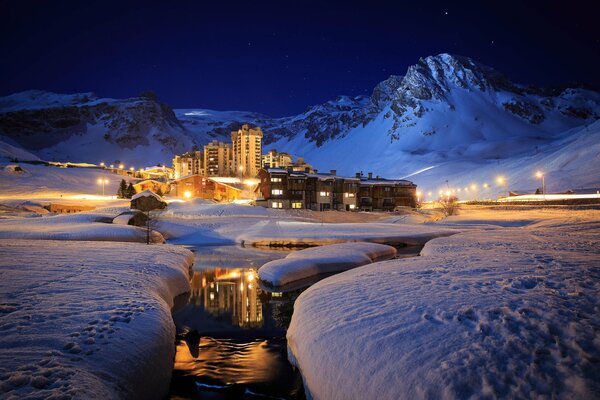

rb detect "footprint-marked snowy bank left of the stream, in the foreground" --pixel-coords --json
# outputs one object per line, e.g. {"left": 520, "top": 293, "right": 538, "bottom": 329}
{"left": 0, "top": 240, "right": 193, "bottom": 399}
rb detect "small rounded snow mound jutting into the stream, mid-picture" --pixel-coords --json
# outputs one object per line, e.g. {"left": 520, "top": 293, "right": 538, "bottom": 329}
{"left": 258, "top": 242, "right": 396, "bottom": 286}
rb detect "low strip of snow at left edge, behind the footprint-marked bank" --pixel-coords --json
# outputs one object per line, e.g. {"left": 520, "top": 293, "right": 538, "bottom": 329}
{"left": 0, "top": 212, "right": 165, "bottom": 243}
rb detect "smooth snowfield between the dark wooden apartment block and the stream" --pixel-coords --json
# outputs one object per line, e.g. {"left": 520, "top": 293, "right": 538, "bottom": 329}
{"left": 157, "top": 201, "right": 456, "bottom": 247}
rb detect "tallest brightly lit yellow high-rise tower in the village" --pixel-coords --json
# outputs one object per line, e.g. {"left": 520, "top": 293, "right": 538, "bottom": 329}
{"left": 231, "top": 124, "right": 263, "bottom": 178}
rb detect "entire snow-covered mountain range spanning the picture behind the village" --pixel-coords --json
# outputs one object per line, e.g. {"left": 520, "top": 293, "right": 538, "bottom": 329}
{"left": 0, "top": 54, "right": 600, "bottom": 197}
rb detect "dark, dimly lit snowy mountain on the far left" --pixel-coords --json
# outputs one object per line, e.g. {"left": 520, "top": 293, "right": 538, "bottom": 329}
{"left": 0, "top": 90, "right": 193, "bottom": 166}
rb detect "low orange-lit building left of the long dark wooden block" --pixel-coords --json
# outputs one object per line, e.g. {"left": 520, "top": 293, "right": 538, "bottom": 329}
{"left": 171, "top": 175, "right": 242, "bottom": 202}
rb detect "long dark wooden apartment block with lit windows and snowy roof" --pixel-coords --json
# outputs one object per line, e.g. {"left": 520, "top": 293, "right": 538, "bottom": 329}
{"left": 257, "top": 168, "right": 417, "bottom": 211}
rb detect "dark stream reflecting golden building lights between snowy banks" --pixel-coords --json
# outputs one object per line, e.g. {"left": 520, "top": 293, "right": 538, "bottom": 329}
{"left": 169, "top": 246, "right": 305, "bottom": 399}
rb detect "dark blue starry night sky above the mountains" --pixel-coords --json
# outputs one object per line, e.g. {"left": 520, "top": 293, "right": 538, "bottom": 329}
{"left": 0, "top": 0, "right": 600, "bottom": 116}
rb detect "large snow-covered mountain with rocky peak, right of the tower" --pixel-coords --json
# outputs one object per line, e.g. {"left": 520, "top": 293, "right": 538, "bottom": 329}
{"left": 267, "top": 54, "right": 600, "bottom": 197}
